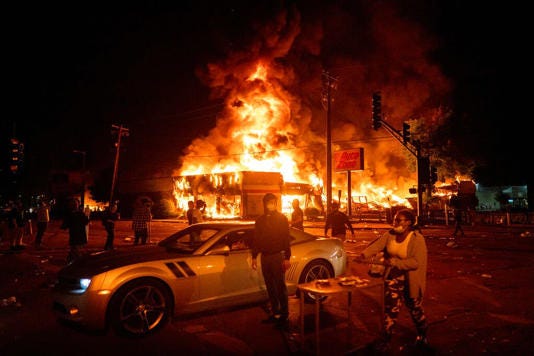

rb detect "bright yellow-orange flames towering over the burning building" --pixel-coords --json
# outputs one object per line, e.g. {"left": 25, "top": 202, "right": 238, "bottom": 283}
{"left": 175, "top": 63, "right": 416, "bottom": 217}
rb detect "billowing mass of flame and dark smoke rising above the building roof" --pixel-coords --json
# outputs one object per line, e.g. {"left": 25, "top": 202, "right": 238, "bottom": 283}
{"left": 175, "top": 2, "right": 450, "bottom": 207}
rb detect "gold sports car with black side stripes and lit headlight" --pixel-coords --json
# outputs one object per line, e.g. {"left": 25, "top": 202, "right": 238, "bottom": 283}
{"left": 53, "top": 222, "right": 347, "bottom": 337}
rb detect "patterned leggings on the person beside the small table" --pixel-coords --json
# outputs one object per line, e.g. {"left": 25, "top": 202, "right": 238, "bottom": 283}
{"left": 384, "top": 277, "right": 428, "bottom": 338}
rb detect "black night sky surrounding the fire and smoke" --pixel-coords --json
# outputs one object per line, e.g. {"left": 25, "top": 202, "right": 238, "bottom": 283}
{"left": 1, "top": 0, "right": 531, "bottom": 197}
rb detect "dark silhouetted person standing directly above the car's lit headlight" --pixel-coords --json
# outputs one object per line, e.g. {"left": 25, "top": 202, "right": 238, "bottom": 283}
{"left": 60, "top": 199, "right": 89, "bottom": 264}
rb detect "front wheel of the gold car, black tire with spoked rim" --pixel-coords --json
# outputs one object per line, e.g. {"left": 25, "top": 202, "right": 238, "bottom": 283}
{"left": 108, "top": 279, "right": 172, "bottom": 338}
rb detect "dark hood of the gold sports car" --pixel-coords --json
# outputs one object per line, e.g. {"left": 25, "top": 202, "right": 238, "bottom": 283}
{"left": 59, "top": 246, "right": 186, "bottom": 277}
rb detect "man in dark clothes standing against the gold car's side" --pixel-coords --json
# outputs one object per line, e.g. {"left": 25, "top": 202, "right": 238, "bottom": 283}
{"left": 252, "top": 193, "right": 291, "bottom": 330}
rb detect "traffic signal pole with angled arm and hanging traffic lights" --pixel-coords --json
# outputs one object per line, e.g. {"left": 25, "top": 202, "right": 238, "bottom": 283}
{"left": 372, "top": 92, "right": 430, "bottom": 221}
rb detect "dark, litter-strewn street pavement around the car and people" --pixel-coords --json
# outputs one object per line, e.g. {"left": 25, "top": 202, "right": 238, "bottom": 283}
{"left": 0, "top": 221, "right": 534, "bottom": 355}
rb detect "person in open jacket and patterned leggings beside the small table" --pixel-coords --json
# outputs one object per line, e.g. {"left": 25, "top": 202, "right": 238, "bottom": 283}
{"left": 357, "top": 209, "right": 428, "bottom": 351}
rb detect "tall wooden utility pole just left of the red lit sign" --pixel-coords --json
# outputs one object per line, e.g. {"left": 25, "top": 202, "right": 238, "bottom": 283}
{"left": 322, "top": 71, "right": 337, "bottom": 215}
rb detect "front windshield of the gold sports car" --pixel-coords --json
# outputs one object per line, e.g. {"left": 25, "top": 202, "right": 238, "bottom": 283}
{"left": 158, "top": 225, "right": 220, "bottom": 254}
